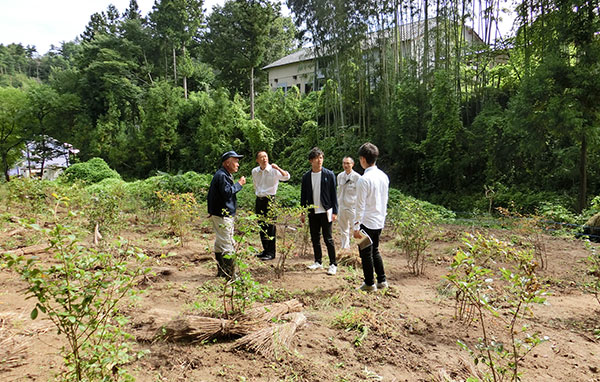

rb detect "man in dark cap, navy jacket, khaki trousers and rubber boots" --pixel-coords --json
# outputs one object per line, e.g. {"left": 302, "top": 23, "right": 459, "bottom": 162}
{"left": 207, "top": 151, "right": 246, "bottom": 279}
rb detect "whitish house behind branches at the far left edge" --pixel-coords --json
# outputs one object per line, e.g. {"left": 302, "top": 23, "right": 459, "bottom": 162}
{"left": 8, "top": 136, "right": 79, "bottom": 180}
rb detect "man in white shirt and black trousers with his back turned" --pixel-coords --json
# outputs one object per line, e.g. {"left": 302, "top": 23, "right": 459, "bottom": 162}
{"left": 354, "top": 143, "right": 390, "bottom": 292}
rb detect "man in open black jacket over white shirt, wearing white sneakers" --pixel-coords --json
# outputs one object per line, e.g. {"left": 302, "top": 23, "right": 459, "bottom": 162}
{"left": 300, "top": 147, "right": 338, "bottom": 275}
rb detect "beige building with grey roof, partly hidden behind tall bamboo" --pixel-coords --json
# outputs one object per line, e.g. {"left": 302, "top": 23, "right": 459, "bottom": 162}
{"left": 263, "top": 19, "right": 484, "bottom": 94}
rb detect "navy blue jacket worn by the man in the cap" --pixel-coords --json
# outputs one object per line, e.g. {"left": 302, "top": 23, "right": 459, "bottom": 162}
{"left": 207, "top": 167, "right": 242, "bottom": 216}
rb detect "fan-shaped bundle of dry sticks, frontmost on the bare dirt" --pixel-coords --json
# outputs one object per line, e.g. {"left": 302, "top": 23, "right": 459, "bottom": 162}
{"left": 233, "top": 313, "right": 306, "bottom": 359}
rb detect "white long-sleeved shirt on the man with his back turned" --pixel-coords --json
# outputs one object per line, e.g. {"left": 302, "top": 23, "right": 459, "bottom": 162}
{"left": 354, "top": 165, "right": 390, "bottom": 230}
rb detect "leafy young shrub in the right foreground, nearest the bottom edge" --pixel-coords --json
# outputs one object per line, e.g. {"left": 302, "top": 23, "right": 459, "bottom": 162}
{"left": 446, "top": 234, "right": 546, "bottom": 382}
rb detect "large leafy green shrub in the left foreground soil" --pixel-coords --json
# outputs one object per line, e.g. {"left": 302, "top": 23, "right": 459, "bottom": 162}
{"left": 3, "top": 198, "right": 149, "bottom": 381}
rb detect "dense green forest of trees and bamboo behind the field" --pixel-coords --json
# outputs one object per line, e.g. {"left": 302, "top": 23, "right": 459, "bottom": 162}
{"left": 0, "top": 0, "right": 600, "bottom": 211}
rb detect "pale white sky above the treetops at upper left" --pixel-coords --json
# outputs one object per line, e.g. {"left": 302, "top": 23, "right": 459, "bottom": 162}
{"left": 0, "top": 0, "right": 225, "bottom": 54}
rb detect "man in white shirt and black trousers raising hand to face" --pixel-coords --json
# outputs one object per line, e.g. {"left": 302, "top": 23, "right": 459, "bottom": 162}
{"left": 252, "top": 151, "right": 290, "bottom": 260}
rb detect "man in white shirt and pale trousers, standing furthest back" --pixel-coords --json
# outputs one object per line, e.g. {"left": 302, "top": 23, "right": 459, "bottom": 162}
{"left": 337, "top": 157, "right": 360, "bottom": 249}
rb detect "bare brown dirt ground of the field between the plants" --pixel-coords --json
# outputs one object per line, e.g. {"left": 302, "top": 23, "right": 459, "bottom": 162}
{"left": 0, "top": 216, "right": 600, "bottom": 382}
